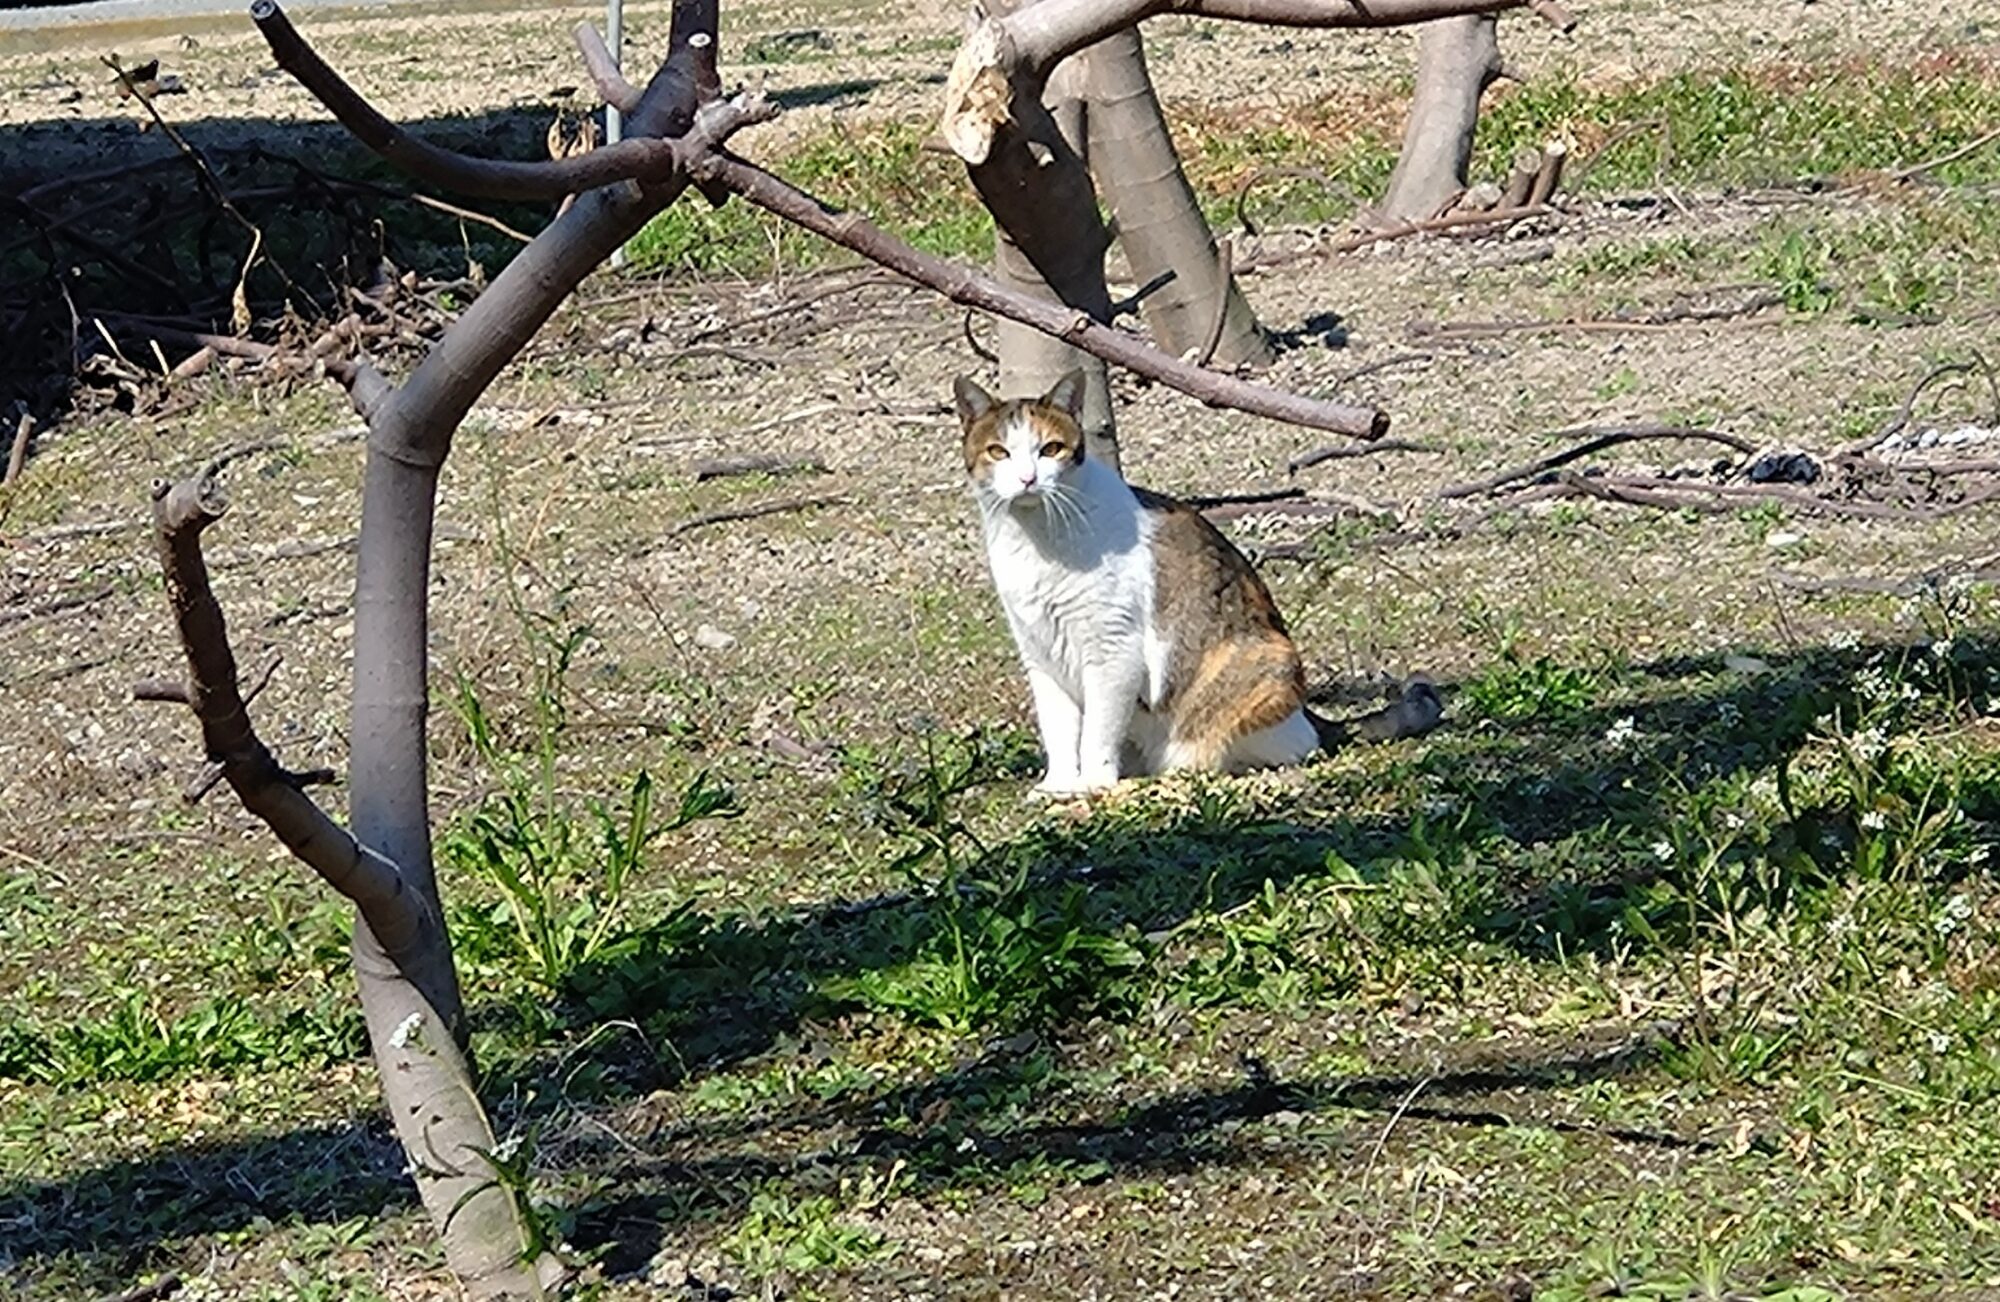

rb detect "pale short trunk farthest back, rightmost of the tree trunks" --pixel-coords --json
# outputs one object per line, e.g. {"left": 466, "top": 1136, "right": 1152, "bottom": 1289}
{"left": 1374, "top": 14, "right": 1500, "bottom": 224}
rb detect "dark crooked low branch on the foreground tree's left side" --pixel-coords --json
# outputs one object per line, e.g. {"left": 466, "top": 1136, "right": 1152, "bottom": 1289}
{"left": 147, "top": 474, "right": 436, "bottom": 952}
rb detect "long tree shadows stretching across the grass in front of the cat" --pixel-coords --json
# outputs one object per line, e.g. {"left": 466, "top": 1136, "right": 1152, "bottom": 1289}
{"left": 0, "top": 638, "right": 2000, "bottom": 1278}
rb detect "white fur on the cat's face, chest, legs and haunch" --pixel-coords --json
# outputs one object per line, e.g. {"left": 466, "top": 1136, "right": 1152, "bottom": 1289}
{"left": 974, "top": 410, "right": 1318, "bottom": 794}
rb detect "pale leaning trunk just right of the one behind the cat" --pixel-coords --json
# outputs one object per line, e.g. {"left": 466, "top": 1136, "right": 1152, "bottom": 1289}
{"left": 1066, "top": 28, "right": 1270, "bottom": 366}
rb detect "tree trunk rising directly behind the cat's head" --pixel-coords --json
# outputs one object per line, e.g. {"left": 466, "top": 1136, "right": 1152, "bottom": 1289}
{"left": 946, "top": 0, "right": 1120, "bottom": 470}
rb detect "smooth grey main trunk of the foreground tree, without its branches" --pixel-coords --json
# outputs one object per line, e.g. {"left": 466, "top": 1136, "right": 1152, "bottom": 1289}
{"left": 350, "top": 181, "right": 662, "bottom": 1298}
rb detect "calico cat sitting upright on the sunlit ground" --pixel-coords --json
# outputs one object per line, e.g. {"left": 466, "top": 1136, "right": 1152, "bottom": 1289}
{"left": 952, "top": 372, "right": 1442, "bottom": 796}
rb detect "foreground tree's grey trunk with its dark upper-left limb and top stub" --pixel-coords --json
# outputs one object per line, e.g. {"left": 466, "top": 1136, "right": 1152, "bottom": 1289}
{"left": 238, "top": 0, "right": 726, "bottom": 1298}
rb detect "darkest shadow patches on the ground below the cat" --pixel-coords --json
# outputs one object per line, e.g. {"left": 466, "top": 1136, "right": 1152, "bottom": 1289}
{"left": 11, "top": 638, "right": 2000, "bottom": 1276}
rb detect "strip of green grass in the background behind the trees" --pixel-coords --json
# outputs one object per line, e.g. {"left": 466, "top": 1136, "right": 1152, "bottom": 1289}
{"left": 612, "top": 51, "right": 2000, "bottom": 288}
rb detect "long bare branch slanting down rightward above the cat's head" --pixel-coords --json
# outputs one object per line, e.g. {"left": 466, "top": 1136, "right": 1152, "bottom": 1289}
{"left": 692, "top": 155, "right": 1388, "bottom": 438}
